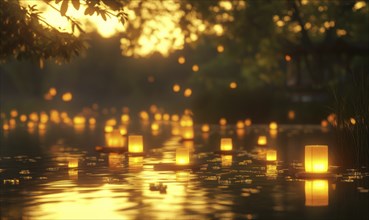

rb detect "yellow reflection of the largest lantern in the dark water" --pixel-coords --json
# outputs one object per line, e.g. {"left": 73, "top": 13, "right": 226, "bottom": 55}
{"left": 305, "top": 180, "right": 329, "bottom": 206}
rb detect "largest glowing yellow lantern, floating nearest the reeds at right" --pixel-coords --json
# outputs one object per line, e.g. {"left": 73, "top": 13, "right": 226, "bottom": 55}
{"left": 305, "top": 145, "right": 328, "bottom": 173}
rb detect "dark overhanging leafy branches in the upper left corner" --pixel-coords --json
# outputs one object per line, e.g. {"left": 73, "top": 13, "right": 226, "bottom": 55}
{"left": 0, "top": 0, "right": 126, "bottom": 67}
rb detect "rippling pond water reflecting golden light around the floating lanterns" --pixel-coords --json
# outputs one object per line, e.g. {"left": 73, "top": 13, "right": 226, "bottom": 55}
{"left": 0, "top": 124, "right": 368, "bottom": 219}
